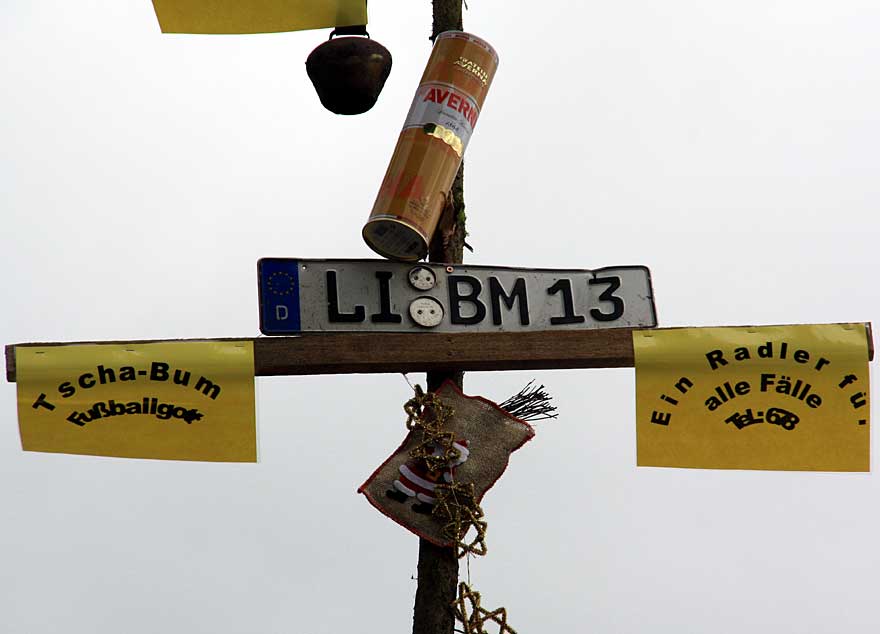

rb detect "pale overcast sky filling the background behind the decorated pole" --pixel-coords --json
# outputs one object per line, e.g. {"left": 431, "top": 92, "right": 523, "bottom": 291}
{"left": 0, "top": 0, "right": 880, "bottom": 634}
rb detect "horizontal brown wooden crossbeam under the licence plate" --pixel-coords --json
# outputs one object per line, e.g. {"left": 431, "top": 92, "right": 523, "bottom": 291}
{"left": 6, "top": 323, "right": 874, "bottom": 382}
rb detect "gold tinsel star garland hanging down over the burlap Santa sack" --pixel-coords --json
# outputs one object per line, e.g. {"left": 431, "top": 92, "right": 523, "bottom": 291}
{"left": 403, "top": 385, "right": 516, "bottom": 634}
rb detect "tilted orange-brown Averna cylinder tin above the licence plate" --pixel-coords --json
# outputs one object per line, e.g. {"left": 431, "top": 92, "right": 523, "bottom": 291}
{"left": 363, "top": 31, "right": 498, "bottom": 262}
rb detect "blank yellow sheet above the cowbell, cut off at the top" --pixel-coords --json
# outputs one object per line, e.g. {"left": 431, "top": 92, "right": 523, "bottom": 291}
{"left": 153, "top": 0, "right": 367, "bottom": 34}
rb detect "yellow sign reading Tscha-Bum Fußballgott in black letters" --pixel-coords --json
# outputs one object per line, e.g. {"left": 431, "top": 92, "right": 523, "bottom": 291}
{"left": 15, "top": 341, "right": 257, "bottom": 462}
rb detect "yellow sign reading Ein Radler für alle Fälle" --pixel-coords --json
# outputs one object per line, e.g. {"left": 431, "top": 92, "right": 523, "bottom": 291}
{"left": 633, "top": 323, "right": 870, "bottom": 471}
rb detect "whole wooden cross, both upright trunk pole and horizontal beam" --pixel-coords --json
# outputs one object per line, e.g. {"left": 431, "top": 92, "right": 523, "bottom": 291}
{"left": 5, "top": 0, "right": 873, "bottom": 634}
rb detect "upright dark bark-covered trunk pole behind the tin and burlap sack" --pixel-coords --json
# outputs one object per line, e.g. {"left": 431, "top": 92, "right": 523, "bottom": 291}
{"left": 413, "top": 0, "right": 466, "bottom": 634}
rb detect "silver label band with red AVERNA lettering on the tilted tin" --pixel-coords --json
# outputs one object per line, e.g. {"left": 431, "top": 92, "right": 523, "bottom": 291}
{"left": 403, "top": 82, "right": 480, "bottom": 156}
